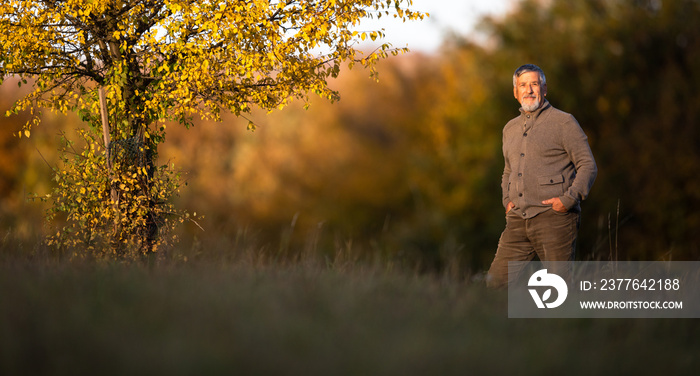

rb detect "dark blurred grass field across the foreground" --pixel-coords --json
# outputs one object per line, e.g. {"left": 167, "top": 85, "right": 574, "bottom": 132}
{"left": 0, "top": 241, "right": 700, "bottom": 375}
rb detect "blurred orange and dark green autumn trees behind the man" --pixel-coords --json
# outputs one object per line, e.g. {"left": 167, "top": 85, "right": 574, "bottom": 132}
{"left": 0, "top": 0, "right": 700, "bottom": 272}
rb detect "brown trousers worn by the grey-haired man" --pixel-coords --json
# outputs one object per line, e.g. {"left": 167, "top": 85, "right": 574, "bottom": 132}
{"left": 486, "top": 209, "right": 581, "bottom": 288}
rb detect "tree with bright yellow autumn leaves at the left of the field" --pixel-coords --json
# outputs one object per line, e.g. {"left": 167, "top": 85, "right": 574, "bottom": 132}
{"left": 0, "top": 0, "right": 423, "bottom": 256}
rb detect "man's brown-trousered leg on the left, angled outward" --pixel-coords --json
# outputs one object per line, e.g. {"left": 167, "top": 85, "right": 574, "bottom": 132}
{"left": 486, "top": 210, "right": 535, "bottom": 288}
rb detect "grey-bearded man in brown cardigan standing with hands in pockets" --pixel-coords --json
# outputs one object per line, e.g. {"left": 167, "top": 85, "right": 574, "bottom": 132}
{"left": 487, "top": 64, "right": 598, "bottom": 288}
